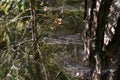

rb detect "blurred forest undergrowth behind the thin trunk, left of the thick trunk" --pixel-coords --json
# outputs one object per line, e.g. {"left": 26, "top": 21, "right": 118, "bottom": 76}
{"left": 0, "top": 0, "right": 86, "bottom": 80}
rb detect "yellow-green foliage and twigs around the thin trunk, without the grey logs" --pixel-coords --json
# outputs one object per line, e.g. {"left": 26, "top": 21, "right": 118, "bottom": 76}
{"left": 0, "top": 0, "right": 83, "bottom": 80}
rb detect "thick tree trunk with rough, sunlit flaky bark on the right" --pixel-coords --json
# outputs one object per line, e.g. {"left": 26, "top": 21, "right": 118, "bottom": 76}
{"left": 84, "top": 0, "right": 120, "bottom": 80}
